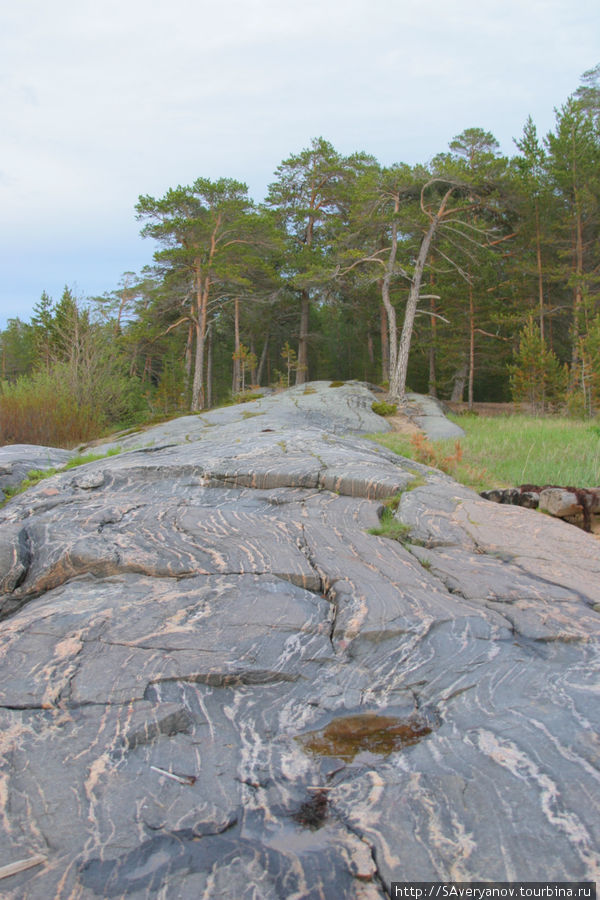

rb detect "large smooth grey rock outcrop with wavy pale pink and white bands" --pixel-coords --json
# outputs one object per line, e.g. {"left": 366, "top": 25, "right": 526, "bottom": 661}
{"left": 0, "top": 383, "right": 600, "bottom": 900}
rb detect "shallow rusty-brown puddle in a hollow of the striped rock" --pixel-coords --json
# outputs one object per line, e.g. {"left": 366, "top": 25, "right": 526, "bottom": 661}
{"left": 296, "top": 713, "right": 432, "bottom": 762}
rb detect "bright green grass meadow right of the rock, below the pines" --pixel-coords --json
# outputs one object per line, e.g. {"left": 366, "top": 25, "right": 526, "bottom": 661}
{"left": 371, "top": 415, "right": 600, "bottom": 491}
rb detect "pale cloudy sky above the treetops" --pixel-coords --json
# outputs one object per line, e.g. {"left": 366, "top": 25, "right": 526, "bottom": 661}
{"left": 0, "top": 0, "right": 600, "bottom": 328}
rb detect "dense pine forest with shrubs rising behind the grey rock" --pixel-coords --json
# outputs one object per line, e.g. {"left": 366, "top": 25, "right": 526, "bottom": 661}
{"left": 0, "top": 65, "right": 600, "bottom": 444}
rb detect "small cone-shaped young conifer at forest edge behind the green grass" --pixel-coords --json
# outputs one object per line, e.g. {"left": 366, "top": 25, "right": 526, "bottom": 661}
{"left": 509, "top": 319, "right": 567, "bottom": 413}
